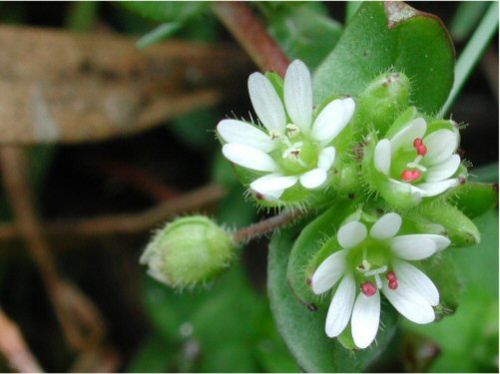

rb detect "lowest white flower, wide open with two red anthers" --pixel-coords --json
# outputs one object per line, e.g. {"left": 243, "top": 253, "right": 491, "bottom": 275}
{"left": 311, "top": 213, "right": 450, "bottom": 348}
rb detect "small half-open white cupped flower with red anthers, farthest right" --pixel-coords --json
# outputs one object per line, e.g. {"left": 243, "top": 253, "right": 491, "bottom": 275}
{"left": 374, "top": 118, "right": 460, "bottom": 202}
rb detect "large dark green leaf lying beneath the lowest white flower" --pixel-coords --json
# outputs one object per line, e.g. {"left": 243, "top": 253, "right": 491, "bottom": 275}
{"left": 267, "top": 222, "right": 396, "bottom": 372}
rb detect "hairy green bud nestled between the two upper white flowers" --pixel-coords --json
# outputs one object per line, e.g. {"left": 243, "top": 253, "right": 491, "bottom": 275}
{"left": 353, "top": 72, "right": 410, "bottom": 134}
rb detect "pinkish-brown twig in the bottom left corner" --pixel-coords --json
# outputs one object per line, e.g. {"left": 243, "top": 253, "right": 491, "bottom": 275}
{"left": 0, "top": 309, "right": 43, "bottom": 373}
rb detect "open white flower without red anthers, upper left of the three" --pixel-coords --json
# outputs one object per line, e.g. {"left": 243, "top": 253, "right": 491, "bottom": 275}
{"left": 217, "top": 60, "right": 355, "bottom": 200}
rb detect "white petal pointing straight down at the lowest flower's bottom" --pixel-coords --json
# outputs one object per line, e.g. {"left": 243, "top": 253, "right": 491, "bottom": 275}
{"left": 351, "top": 292, "right": 380, "bottom": 349}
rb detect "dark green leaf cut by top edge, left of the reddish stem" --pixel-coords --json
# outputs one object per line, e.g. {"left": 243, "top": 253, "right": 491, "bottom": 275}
{"left": 120, "top": 1, "right": 210, "bottom": 22}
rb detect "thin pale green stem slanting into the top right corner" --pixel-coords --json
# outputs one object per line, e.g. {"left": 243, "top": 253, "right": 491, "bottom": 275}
{"left": 438, "top": 2, "right": 498, "bottom": 117}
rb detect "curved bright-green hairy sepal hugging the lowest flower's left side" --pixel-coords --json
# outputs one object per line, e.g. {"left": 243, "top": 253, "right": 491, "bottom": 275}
{"left": 287, "top": 200, "right": 356, "bottom": 310}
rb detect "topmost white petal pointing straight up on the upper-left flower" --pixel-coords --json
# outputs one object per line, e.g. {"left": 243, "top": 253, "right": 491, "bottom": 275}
{"left": 284, "top": 60, "right": 312, "bottom": 132}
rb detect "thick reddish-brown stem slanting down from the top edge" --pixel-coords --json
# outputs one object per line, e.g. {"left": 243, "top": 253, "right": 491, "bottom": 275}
{"left": 212, "top": 1, "right": 290, "bottom": 77}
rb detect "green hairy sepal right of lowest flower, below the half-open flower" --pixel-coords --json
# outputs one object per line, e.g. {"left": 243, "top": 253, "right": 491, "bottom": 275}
{"left": 410, "top": 202, "right": 481, "bottom": 247}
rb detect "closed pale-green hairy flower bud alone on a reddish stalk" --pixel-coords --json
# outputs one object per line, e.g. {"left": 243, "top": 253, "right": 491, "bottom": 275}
{"left": 140, "top": 216, "right": 236, "bottom": 288}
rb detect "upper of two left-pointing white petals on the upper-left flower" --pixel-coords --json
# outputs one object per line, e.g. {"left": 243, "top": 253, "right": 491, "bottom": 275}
{"left": 217, "top": 119, "right": 276, "bottom": 153}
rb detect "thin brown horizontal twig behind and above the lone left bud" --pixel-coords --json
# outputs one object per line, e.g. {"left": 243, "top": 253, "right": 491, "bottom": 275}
{"left": 0, "top": 184, "right": 227, "bottom": 241}
